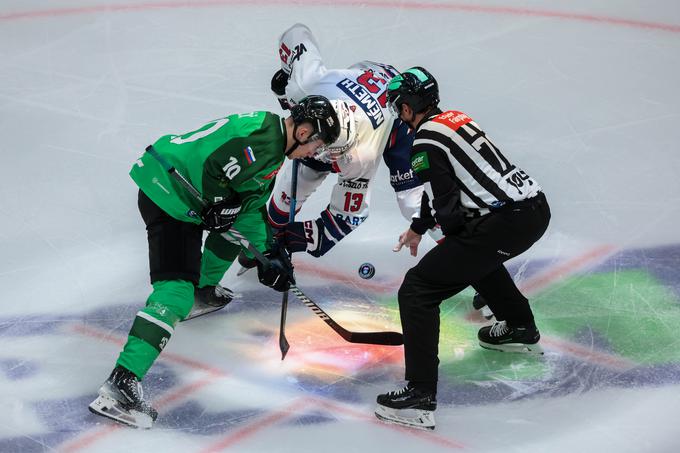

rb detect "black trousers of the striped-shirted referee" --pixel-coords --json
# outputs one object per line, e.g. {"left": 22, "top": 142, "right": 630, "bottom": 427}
{"left": 399, "top": 193, "right": 550, "bottom": 392}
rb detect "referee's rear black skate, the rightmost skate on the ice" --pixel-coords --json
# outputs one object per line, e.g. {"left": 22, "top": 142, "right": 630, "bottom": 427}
{"left": 477, "top": 321, "right": 543, "bottom": 354}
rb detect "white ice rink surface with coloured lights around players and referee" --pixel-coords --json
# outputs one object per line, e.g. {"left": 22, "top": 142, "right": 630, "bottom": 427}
{"left": 0, "top": 0, "right": 680, "bottom": 453}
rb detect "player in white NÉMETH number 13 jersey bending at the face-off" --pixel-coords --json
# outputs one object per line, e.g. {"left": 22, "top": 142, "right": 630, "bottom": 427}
{"left": 260, "top": 24, "right": 436, "bottom": 258}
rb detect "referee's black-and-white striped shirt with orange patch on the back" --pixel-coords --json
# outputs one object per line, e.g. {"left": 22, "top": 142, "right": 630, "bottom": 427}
{"left": 411, "top": 109, "right": 541, "bottom": 234}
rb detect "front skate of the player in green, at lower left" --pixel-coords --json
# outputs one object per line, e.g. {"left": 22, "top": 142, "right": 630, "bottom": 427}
{"left": 89, "top": 365, "right": 158, "bottom": 429}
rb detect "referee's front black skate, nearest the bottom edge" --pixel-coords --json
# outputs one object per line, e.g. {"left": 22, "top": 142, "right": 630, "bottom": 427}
{"left": 375, "top": 386, "right": 437, "bottom": 429}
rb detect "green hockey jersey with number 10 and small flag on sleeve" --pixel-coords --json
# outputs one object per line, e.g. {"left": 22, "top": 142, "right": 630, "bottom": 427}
{"left": 130, "top": 112, "right": 286, "bottom": 224}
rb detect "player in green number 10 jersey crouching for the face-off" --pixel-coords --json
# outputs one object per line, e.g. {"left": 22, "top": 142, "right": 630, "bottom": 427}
{"left": 89, "top": 96, "right": 340, "bottom": 428}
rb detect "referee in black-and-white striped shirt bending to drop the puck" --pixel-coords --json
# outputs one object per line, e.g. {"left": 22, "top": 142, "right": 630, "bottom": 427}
{"left": 376, "top": 67, "right": 550, "bottom": 428}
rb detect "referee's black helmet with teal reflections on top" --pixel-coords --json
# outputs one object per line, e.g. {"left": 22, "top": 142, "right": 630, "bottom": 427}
{"left": 387, "top": 66, "right": 439, "bottom": 115}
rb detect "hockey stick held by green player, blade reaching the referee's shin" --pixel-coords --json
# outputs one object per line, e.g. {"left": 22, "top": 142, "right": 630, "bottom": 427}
{"left": 146, "top": 146, "right": 404, "bottom": 346}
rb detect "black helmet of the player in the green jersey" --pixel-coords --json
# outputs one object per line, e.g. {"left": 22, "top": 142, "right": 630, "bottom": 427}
{"left": 290, "top": 95, "right": 340, "bottom": 145}
